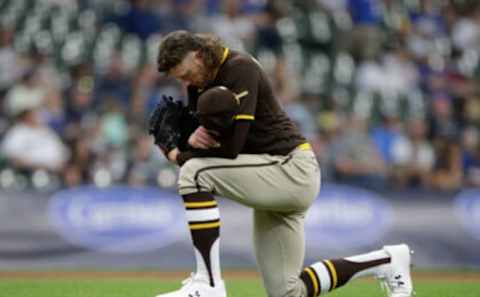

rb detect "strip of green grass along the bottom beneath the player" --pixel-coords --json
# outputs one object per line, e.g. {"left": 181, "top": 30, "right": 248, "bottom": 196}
{"left": 0, "top": 278, "right": 480, "bottom": 297}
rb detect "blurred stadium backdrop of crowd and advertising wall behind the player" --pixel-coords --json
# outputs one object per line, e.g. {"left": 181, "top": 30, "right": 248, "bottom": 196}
{"left": 0, "top": 0, "right": 480, "bottom": 270}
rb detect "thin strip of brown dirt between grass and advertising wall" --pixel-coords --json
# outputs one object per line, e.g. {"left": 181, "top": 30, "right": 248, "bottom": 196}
{"left": 0, "top": 270, "right": 480, "bottom": 283}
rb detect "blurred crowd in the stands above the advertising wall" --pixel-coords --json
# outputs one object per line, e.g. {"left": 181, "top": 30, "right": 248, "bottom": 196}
{"left": 0, "top": 0, "right": 480, "bottom": 191}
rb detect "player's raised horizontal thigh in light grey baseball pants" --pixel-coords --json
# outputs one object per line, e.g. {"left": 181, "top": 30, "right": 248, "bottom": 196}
{"left": 179, "top": 154, "right": 319, "bottom": 211}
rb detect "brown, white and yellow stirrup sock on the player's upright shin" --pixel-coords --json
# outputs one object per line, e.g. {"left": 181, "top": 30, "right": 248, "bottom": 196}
{"left": 183, "top": 192, "right": 221, "bottom": 287}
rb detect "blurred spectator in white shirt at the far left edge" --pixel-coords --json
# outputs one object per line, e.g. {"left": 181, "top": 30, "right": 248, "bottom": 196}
{"left": 2, "top": 108, "right": 69, "bottom": 173}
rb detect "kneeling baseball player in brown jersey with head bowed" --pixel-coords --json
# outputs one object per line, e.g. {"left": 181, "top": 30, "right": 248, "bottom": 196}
{"left": 149, "top": 31, "right": 412, "bottom": 297}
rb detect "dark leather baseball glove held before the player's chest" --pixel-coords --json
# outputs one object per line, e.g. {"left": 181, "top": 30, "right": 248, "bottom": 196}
{"left": 148, "top": 95, "right": 184, "bottom": 154}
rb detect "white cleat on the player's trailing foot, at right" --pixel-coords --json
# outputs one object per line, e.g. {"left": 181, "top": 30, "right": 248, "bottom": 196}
{"left": 378, "top": 244, "right": 413, "bottom": 297}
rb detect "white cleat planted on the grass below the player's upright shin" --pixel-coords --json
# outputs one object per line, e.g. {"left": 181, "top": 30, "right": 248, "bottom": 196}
{"left": 155, "top": 274, "right": 227, "bottom": 297}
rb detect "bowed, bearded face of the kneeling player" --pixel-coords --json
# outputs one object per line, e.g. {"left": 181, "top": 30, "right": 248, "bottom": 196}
{"left": 169, "top": 52, "right": 208, "bottom": 87}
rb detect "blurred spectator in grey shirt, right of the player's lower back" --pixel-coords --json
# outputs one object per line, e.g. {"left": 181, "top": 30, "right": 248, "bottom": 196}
{"left": 332, "top": 114, "right": 386, "bottom": 190}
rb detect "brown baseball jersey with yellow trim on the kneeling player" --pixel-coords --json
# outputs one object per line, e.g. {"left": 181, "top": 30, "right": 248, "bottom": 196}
{"left": 177, "top": 48, "right": 306, "bottom": 164}
